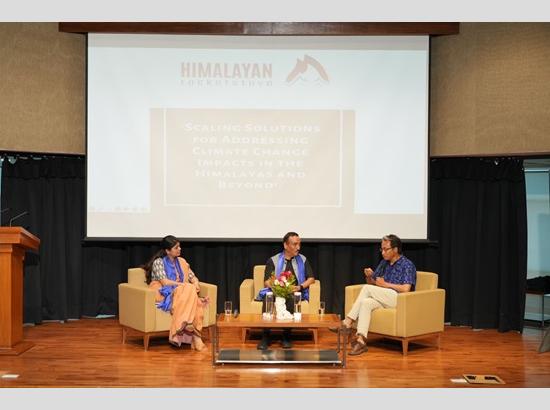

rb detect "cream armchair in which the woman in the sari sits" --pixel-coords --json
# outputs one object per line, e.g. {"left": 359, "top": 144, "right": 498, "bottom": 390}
{"left": 118, "top": 268, "right": 218, "bottom": 350}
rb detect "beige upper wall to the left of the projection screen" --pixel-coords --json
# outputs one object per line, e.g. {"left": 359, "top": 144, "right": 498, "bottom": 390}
{"left": 0, "top": 23, "right": 86, "bottom": 154}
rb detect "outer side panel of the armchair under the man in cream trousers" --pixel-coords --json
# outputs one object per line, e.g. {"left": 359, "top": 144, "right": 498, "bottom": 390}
{"left": 396, "top": 289, "right": 445, "bottom": 337}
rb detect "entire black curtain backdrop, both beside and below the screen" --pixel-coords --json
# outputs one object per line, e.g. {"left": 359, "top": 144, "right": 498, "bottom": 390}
{"left": 2, "top": 157, "right": 527, "bottom": 331}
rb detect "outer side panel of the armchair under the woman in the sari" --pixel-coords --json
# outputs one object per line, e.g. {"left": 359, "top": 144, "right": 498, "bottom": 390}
{"left": 118, "top": 283, "right": 156, "bottom": 332}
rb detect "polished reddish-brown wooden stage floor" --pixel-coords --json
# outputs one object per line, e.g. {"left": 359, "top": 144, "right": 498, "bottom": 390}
{"left": 0, "top": 319, "right": 550, "bottom": 388}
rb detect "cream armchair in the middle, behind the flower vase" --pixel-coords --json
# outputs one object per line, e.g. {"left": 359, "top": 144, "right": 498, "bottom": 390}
{"left": 239, "top": 265, "right": 321, "bottom": 344}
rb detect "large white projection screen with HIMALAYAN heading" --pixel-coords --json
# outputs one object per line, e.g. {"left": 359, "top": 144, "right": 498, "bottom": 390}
{"left": 87, "top": 34, "right": 429, "bottom": 240}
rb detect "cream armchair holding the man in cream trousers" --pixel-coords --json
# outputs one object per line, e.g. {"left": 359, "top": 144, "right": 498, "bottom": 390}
{"left": 345, "top": 272, "right": 445, "bottom": 355}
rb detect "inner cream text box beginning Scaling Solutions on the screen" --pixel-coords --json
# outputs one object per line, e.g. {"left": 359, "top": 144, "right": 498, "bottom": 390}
{"left": 160, "top": 109, "right": 341, "bottom": 207}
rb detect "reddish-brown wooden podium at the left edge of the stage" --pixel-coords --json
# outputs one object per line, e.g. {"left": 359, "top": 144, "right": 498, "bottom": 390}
{"left": 0, "top": 227, "right": 40, "bottom": 355}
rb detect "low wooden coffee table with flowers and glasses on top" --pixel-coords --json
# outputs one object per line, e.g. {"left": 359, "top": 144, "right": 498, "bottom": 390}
{"left": 212, "top": 313, "right": 347, "bottom": 367}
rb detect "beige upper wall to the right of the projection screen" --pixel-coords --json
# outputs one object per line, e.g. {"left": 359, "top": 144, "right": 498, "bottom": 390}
{"left": 430, "top": 23, "right": 550, "bottom": 156}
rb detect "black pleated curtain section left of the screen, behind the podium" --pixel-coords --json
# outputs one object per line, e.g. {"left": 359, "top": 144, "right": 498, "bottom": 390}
{"left": 2, "top": 157, "right": 85, "bottom": 323}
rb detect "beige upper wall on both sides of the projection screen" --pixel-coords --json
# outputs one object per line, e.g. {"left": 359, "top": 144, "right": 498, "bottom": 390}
{"left": 0, "top": 23, "right": 550, "bottom": 156}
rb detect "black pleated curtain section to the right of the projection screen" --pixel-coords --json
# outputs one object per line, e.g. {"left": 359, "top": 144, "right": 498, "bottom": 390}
{"left": 429, "top": 158, "right": 527, "bottom": 331}
